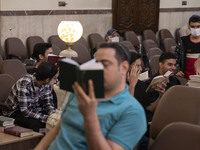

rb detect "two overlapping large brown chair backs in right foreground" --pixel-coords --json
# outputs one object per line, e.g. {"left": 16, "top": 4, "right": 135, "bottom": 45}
{"left": 149, "top": 86, "right": 200, "bottom": 150}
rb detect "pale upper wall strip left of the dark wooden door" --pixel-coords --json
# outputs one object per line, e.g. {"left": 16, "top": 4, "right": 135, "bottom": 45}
{"left": 1, "top": 0, "right": 112, "bottom": 11}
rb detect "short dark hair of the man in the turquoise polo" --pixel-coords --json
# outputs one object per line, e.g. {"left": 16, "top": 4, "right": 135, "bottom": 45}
{"left": 99, "top": 43, "right": 131, "bottom": 64}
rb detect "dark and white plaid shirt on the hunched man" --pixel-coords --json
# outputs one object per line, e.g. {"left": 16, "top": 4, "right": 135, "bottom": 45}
{"left": 3, "top": 74, "right": 55, "bottom": 123}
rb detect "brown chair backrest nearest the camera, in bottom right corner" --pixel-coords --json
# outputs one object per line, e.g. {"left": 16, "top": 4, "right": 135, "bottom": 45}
{"left": 149, "top": 122, "right": 200, "bottom": 150}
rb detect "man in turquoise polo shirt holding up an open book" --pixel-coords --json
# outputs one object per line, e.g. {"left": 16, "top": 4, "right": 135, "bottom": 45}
{"left": 36, "top": 43, "right": 146, "bottom": 150}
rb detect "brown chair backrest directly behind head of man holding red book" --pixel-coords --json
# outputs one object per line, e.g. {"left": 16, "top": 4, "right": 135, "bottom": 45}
{"left": 26, "top": 36, "right": 44, "bottom": 57}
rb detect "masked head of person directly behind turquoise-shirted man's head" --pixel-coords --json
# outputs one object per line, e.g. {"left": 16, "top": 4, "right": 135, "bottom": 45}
{"left": 105, "top": 29, "right": 120, "bottom": 43}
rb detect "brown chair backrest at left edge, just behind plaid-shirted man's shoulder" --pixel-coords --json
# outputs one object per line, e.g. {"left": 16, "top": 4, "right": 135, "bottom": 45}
{"left": 1, "top": 59, "right": 27, "bottom": 81}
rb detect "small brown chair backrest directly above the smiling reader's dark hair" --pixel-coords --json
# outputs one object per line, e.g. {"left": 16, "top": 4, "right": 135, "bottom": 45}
{"left": 163, "top": 38, "right": 176, "bottom": 53}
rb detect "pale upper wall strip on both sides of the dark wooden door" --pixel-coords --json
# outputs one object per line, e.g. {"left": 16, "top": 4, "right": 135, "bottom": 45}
{"left": 0, "top": 0, "right": 200, "bottom": 11}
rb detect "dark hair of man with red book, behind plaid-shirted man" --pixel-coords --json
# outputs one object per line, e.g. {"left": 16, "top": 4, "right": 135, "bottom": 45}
{"left": 32, "top": 43, "right": 52, "bottom": 61}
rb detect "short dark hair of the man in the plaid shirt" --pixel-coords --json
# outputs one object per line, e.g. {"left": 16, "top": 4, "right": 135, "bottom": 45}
{"left": 35, "top": 61, "right": 58, "bottom": 81}
